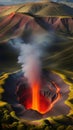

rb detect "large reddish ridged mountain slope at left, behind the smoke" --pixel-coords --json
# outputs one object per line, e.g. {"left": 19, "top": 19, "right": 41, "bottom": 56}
{"left": 0, "top": 13, "right": 49, "bottom": 42}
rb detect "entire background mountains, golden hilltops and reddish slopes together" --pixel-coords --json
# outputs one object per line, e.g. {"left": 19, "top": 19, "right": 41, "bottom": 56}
{"left": 0, "top": 2, "right": 73, "bottom": 43}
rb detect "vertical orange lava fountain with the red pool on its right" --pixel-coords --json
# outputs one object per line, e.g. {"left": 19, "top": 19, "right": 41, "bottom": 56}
{"left": 31, "top": 83, "right": 50, "bottom": 114}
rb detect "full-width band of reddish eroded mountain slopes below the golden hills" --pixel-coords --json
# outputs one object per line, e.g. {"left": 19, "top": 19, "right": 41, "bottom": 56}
{"left": 0, "top": 13, "right": 73, "bottom": 42}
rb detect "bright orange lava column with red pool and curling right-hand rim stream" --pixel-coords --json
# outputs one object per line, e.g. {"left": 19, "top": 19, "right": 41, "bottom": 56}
{"left": 27, "top": 82, "right": 61, "bottom": 114}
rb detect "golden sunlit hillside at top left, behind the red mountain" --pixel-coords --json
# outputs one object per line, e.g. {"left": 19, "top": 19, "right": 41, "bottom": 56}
{"left": 0, "top": 2, "right": 48, "bottom": 17}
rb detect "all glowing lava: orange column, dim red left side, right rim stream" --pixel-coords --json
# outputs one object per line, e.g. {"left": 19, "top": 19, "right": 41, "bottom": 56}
{"left": 18, "top": 81, "right": 61, "bottom": 114}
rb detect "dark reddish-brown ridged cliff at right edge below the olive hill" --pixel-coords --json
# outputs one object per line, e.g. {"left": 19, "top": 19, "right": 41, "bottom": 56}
{"left": 47, "top": 17, "right": 73, "bottom": 34}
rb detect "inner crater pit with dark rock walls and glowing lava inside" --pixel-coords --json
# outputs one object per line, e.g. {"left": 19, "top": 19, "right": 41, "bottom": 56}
{"left": 16, "top": 71, "right": 61, "bottom": 115}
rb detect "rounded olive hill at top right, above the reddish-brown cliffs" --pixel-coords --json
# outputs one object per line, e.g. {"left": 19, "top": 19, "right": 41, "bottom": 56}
{"left": 36, "top": 2, "right": 73, "bottom": 17}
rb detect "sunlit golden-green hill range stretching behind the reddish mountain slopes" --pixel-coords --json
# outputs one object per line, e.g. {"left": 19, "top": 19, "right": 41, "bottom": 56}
{"left": 0, "top": 2, "right": 73, "bottom": 17}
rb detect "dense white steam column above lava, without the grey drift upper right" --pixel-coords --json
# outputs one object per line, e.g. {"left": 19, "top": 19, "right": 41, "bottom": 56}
{"left": 18, "top": 44, "right": 41, "bottom": 86}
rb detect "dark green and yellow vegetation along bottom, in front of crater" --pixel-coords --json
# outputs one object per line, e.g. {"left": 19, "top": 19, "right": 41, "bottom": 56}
{"left": 0, "top": 106, "right": 73, "bottom": 130}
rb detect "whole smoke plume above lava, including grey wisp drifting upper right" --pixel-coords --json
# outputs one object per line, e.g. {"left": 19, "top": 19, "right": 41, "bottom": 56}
{"left": 18, "top": 33, "right": 53, "bottom": 86}
